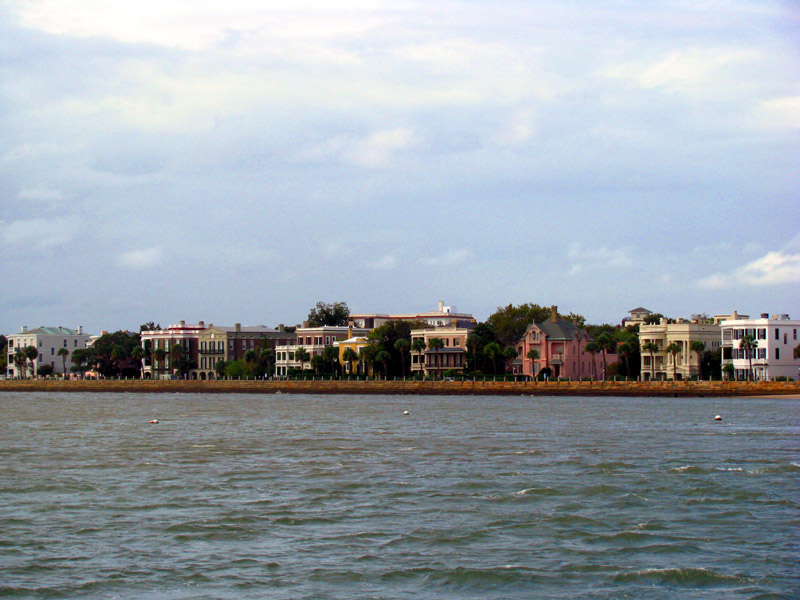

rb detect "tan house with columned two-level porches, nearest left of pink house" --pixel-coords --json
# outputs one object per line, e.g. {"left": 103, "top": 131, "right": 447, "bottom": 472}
{"left": 411, "top": 323, "right": 474, "bottom": 377}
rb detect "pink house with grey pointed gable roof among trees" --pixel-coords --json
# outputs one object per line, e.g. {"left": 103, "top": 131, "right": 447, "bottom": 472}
{"left": 515, "top": 306, "right": 604, "bottom": 380}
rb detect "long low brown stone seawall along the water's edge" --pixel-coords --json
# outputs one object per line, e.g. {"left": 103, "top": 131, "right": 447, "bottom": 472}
{"left": 0, "top": 379, "right": 800, "bottom": 399}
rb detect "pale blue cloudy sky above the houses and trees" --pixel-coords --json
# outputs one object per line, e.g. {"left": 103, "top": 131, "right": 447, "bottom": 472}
{"left": 0, "top": 0, "right": 800, "bottom": 333}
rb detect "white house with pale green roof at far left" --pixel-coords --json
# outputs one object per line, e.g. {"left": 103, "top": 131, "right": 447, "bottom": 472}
{"left": 7, "top": 326, "right": 91, "bottom": 377}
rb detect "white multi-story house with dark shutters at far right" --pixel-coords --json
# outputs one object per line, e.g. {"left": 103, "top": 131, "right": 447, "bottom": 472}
{"left": 720, "top": 313, "right": 800, "bottom": 381}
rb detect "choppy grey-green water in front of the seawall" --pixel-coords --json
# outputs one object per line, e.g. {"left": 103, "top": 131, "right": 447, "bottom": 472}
{"left": 0, "top": 394, "right": 800, "bottom": 600}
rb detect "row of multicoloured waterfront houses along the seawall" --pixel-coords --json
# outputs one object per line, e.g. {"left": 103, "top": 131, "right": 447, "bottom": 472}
{"left": 7, "top": 302, "right": 800, "bottom": 380}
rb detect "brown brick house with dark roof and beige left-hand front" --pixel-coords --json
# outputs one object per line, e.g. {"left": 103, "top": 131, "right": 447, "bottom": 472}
{"left": 195, "top": 323, "right": 295, "bottom": 380}
